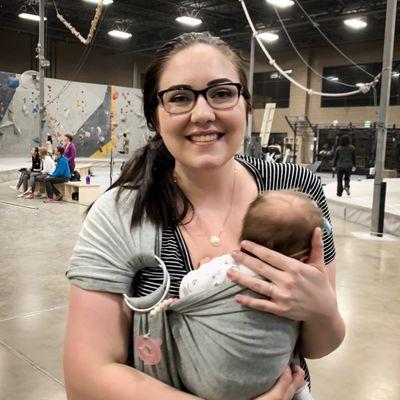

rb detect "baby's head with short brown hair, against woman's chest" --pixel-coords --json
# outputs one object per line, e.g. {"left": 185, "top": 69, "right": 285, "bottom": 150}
{"left": 240, "top": 190, "right": 323, "bottom": 261}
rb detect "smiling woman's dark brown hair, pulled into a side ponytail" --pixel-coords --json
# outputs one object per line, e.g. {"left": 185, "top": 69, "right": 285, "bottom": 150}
{"left": 106, "top": 33, "right": 251, "bottom": 228}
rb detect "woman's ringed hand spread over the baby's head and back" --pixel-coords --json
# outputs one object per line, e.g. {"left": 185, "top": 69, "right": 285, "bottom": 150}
{"left": 227, "top": 228, "right": 337, "bottom": 321}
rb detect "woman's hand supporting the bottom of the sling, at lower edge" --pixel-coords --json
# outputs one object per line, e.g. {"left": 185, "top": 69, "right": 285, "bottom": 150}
{"left": 254, "top": 365, "right": 305, "bottom": 400}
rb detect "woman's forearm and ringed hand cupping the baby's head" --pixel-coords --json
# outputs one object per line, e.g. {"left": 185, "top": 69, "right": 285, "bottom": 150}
{"left": 228, "top": 228, "right": 345, "bottom": 358}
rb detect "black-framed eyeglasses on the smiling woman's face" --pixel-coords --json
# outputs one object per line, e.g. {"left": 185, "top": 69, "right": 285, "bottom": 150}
{"left": 158, "top": 82, "right": 242, "bottom": 114}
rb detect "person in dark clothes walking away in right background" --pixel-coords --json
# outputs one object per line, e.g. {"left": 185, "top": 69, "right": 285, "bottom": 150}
{"left": 332, "top": 135, "right": 356, "bottom": 197}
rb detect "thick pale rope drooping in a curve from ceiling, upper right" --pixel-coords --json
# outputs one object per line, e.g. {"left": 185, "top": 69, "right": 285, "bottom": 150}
{"left": 239, "top": 0, "right": 380, "bottom": 97}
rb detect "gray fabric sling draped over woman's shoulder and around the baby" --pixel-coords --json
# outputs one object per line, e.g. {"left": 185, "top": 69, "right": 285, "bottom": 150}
{"left": 67, "top": 189, "right": 299, "bottom": 400}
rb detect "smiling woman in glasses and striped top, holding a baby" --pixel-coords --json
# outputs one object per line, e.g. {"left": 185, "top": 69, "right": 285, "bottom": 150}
{"left": 64, "top": 34, "right": 344, "bottom": 400}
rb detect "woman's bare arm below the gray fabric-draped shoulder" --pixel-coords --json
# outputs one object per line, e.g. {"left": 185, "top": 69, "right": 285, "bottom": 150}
{"left": 64, "top": 285, "right": 198, "bottom": 400}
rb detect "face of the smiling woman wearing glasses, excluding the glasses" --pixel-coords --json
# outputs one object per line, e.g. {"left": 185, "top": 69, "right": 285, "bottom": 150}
{"left": 157, "top": 44, "right": 246, "bottom": 169}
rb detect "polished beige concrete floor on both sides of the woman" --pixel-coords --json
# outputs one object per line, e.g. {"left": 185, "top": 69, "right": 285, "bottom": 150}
{"left": 0, "top": 170, "right": 400, "bottom": 400}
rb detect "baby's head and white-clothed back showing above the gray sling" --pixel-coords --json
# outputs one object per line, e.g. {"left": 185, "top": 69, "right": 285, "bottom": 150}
{"left": 179, "top": 190, "right": 323, "bottom": 299}
